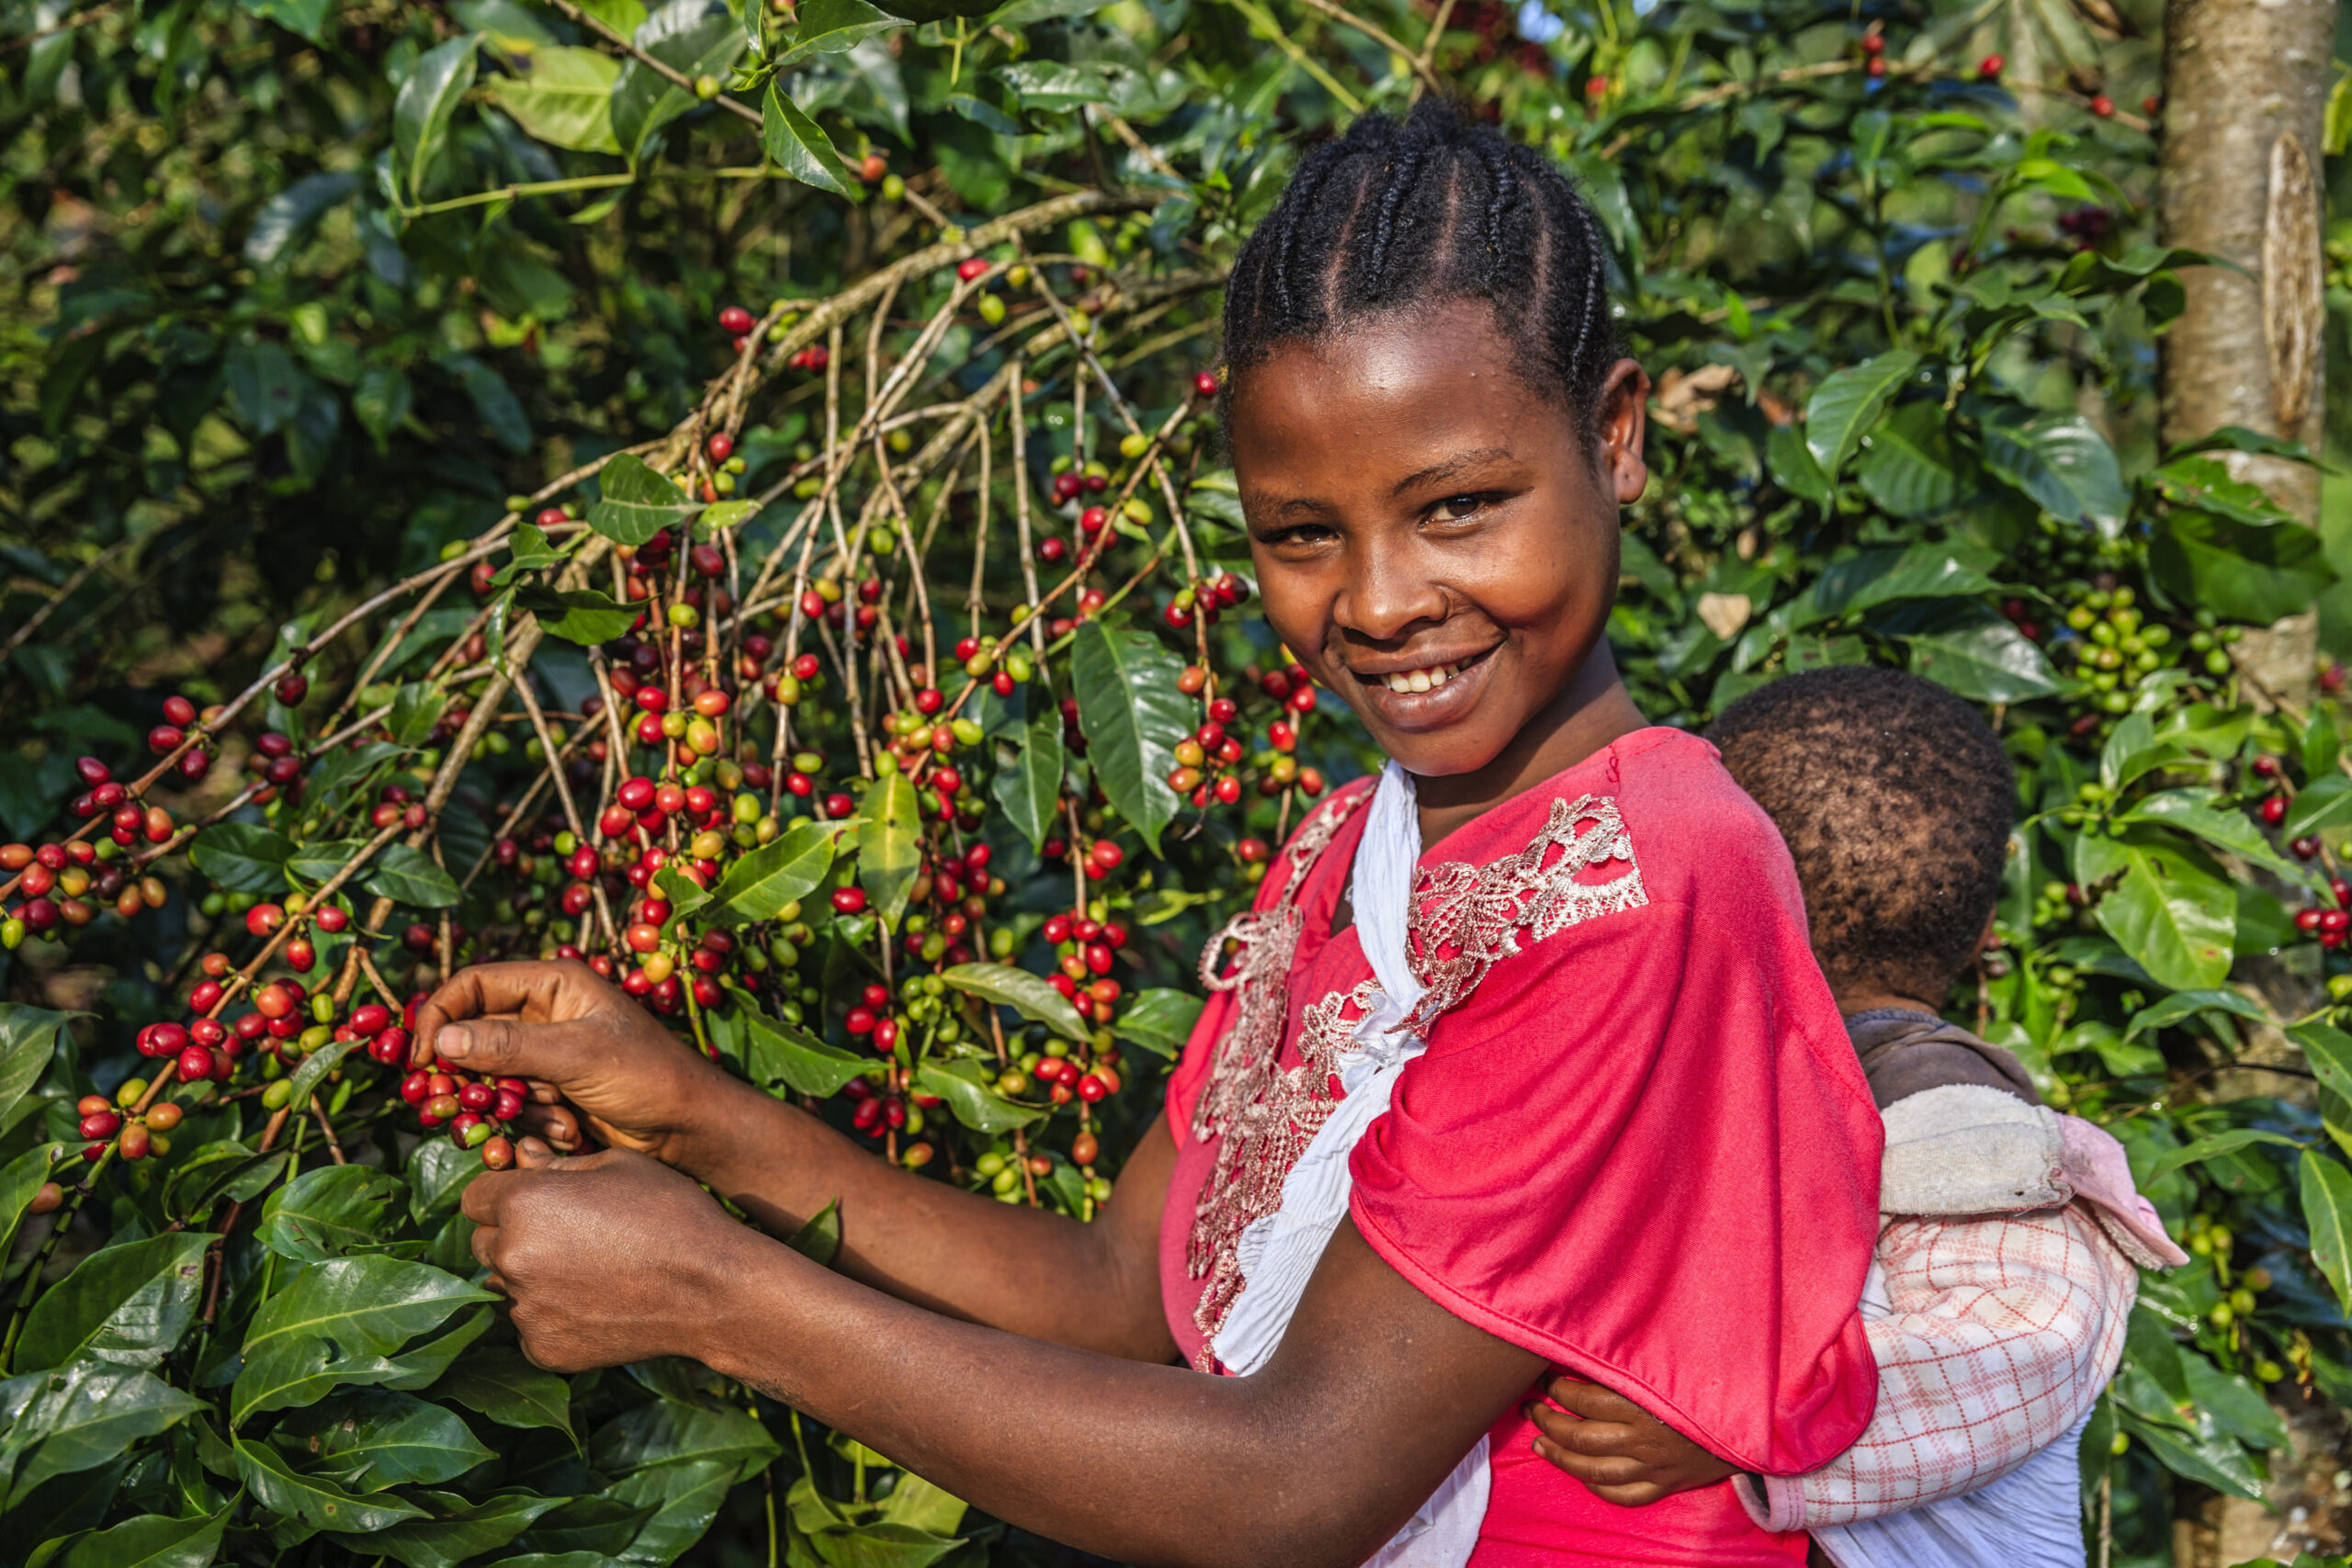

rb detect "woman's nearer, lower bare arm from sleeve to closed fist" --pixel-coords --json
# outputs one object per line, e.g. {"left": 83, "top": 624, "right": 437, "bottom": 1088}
{"left": 466, "top": 1152, "right": 1543, "bottom": 1568}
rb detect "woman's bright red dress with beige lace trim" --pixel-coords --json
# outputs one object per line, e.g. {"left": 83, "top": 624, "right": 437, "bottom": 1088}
{"left": 1159, "top": 728, "right": 1882, "bottom": 1568}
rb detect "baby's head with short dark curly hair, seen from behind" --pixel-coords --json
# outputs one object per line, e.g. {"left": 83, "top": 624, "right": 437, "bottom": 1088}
{"left": 1708, "top": 665, "right": 2018, "bottom": 1006}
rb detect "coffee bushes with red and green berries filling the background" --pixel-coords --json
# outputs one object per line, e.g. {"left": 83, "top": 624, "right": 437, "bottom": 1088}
{"left": 0, "top": 0, "right": 2352, "bottom": 1568}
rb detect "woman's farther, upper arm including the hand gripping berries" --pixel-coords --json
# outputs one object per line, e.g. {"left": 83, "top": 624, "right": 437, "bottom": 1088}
{"left": 416, "top": 964, "right": 1176, "bottom": 1361}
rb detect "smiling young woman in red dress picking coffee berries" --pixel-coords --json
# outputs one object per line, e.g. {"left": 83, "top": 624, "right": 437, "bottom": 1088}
{"left": 419, "top": 106, "right": 1879, "bottom": 1568}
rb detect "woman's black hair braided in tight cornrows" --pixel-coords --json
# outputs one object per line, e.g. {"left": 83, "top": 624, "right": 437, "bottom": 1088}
{"left": 1226, "top": 98, "right": 1616, "bottom": 434}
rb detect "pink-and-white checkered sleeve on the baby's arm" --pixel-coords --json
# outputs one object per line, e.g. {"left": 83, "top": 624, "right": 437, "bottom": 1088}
{"left": 1738, "top": 1203, "right": 2141, "bottom": 1530}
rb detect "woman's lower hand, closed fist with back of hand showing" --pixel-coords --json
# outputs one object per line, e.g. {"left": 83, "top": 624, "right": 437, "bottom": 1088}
{"left": 466, "top": 1138, "right": 751, "bottom": 1373}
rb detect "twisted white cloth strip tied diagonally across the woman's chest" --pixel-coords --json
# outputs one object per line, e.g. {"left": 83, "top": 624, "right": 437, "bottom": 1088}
{"left": 1214, "top": 761, "right": 1488, "bottom": 1568}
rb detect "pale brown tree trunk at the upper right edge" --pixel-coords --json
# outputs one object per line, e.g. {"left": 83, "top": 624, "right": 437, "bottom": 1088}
{"left": 2157, "top": 0, "right": 2335, "bottom": 703}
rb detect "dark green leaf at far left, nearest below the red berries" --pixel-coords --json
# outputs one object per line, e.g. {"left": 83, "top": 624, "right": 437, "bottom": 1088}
{"left": 12, "top": 1232, "right": 214, "bottom": 1373}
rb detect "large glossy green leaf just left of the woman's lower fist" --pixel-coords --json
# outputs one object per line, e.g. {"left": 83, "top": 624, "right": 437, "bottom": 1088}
{"left": 228, "top": 1253, "right": 496, "bottom": 1427}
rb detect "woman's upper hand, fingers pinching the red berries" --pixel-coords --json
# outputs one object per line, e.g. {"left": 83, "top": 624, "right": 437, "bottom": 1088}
{"left": 416, "top": 964, "right": 743, "bottom": 1168}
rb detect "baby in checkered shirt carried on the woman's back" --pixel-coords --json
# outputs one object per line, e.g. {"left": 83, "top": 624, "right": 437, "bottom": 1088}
{"left": 1532, "top": 668, "right": 2188, "bottom": 1568}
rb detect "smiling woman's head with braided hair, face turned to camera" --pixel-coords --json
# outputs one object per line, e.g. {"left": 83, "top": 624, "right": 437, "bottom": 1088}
{"left": 1226, "top": 101, "right": 1649, "bottom": 776}
